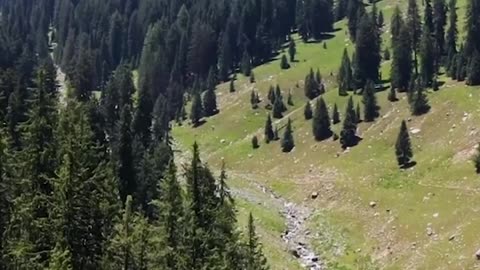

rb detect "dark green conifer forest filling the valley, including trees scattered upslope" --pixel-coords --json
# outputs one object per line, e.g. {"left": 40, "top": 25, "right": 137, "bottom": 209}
{"left": 0, "top": 0, "right": 480, "bottom": 270}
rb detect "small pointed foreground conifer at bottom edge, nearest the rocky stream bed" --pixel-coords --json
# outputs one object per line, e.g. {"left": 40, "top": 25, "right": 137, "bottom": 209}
{"left": 245, "top": 213, "right": 269, "bottom": 270}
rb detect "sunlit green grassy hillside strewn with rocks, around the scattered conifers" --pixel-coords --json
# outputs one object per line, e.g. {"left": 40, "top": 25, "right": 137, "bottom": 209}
{"left": 173, "top": 0, "right": 480, "bottom": 269}
